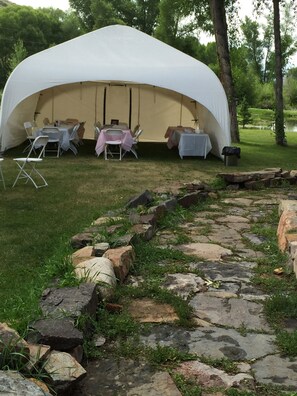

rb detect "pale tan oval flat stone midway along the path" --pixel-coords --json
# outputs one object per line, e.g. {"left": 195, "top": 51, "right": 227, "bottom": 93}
{"left": 176, "top": 243, "right": 232, "bottom": 260}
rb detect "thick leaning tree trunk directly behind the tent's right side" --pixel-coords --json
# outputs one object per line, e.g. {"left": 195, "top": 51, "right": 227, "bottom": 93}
{"left": 209, "top": 0, "right": 240, "bottom": 143}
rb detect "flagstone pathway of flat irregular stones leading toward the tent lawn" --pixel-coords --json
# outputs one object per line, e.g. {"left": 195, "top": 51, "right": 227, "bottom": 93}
{"left": 73, "top": 192, "right": 297, "bottom": 396}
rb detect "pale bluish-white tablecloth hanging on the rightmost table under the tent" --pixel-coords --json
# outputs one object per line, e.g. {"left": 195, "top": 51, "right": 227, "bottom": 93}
{"left": 178, "top": 133, "right": 212, "bottom": 158}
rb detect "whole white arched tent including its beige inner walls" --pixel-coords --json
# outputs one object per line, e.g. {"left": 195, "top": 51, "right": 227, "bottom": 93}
{"left": 0, "top": 25, "right": 231, "bottom": 157}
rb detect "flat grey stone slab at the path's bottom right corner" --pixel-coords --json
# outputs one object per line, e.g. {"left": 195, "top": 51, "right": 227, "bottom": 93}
{"left": 252, "top": 355, "right": 297, "bottom": 391}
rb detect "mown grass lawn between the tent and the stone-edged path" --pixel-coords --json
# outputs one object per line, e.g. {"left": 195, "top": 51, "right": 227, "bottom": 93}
{"left": 0, "top": 130, "right": 297, "bottom": 330}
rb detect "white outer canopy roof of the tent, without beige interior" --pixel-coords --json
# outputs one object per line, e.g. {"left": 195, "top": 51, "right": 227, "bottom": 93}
{"left": 0, "top": 25, "right": 230, "bottom": 150}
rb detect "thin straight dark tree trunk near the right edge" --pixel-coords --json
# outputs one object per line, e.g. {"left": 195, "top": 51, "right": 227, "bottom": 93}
{"left": 273, "top": 0, "right": 286, "bottom": 146}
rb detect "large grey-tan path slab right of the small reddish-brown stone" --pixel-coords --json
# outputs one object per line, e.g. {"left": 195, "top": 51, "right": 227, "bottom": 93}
{"left": 190, "top": 294, "right": 271, "bottom": 331}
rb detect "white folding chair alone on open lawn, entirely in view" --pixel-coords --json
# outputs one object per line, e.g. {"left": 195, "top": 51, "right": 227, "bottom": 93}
{"left": 12, "top": 136, "right": 48, "bottom": 188}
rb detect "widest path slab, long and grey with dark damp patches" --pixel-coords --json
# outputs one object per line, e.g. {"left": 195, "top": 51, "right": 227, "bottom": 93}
{"left": 141, "top": 325, "right": 277, "bottom": 361}
